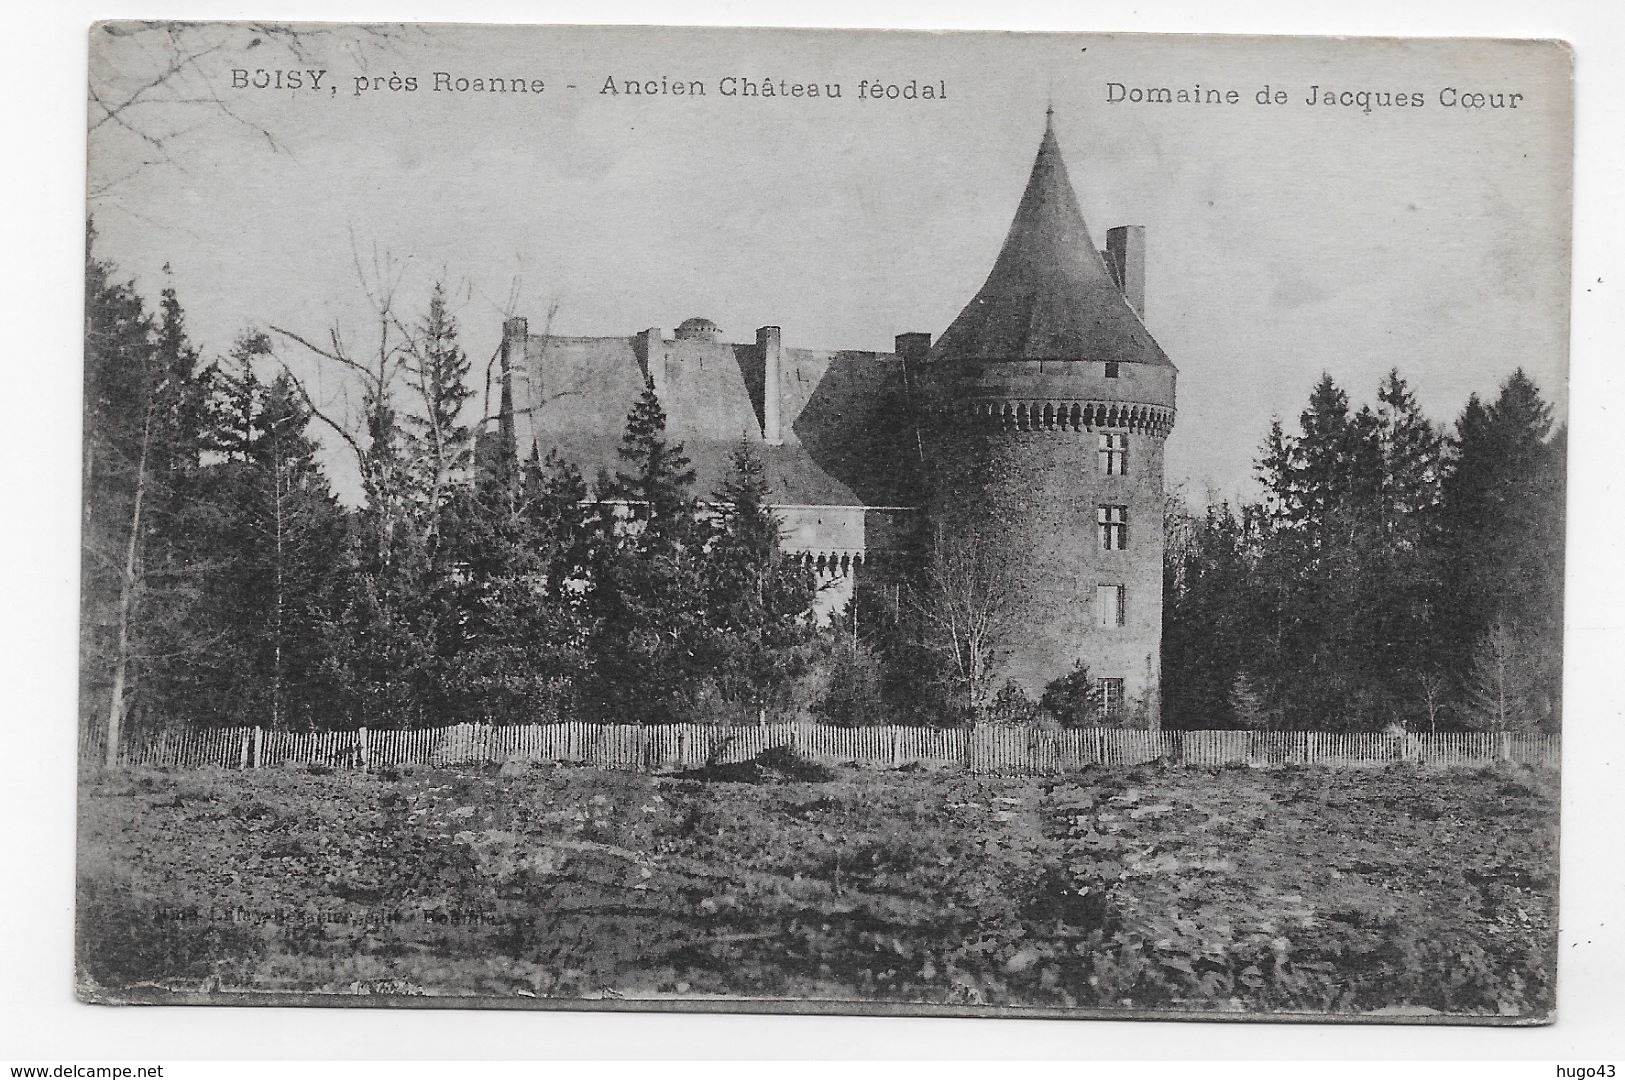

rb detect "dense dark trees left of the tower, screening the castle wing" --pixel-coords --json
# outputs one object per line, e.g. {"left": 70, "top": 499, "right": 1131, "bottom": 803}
{"left": 81, "top": 233, "right": 819, "bottom": 756}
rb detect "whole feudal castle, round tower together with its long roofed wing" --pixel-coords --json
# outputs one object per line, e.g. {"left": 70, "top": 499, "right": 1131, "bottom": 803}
{"left": 487, "top": 113, "right": 1177, "bottom": 724}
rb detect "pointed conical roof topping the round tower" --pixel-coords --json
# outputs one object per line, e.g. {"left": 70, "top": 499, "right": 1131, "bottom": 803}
{"left": 933, "top": 120, "right": 1168, "bottom": 364}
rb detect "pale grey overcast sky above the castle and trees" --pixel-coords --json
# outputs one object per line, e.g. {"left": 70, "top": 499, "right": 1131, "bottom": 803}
{"left": 91, "top": 28, "right": 1571, "bottom": 497}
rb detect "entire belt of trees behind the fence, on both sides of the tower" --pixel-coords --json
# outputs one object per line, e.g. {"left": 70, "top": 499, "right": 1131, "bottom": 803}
{"left": 81, "top": 231, "right": 1563, "bottom": 747}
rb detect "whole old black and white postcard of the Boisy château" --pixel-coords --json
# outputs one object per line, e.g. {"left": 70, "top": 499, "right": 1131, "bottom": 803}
{"left": 73, "top": 21, "right": 1573, "bottom": 1025}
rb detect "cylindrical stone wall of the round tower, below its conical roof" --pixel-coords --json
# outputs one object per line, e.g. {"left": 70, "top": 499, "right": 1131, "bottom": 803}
{"left": 933, "top": 361, "right": 1173, "bottom": 723}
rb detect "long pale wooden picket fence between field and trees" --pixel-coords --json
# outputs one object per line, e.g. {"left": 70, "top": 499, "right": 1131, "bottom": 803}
{"left": 98, "top": 723, "right": 1560, "bottom": 775}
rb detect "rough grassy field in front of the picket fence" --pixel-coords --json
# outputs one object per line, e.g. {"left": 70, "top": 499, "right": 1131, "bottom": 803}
{"left": 80, "top": 753, "right": 1557, "bottom": 1017}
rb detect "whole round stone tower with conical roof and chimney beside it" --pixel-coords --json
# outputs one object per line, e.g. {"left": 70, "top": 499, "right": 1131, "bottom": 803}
{"left": 926, "top": 111, "right": 1177, "bottom": 726}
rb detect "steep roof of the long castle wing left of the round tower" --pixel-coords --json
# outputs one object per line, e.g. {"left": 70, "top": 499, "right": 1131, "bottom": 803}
{"left": 514, "top": 336, "right": 918, "bottom": 507}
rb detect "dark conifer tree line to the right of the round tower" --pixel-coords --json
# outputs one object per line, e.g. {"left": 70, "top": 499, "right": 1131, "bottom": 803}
{"left": 1162, "top": 370, "right": 1567, "bottom": 731}
